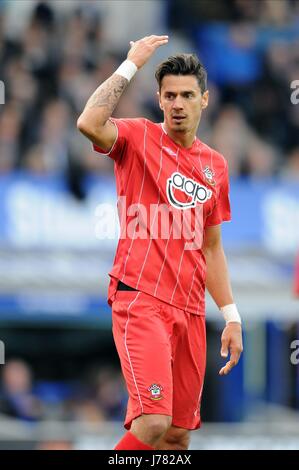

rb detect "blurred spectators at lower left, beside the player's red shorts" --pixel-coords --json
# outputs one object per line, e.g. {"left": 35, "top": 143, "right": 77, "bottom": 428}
{"left": 0, "top": 358, "right": 127, "bottom": 424}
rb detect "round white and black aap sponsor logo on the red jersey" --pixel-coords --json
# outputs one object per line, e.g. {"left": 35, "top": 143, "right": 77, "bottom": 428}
{"left": 166, "top": 171, "right": 212, "bottom": 210}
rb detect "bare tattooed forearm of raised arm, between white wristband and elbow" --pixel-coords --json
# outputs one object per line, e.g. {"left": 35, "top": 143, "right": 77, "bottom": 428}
{"left": 82, "top": 74, "right": 129, "bottom": 125}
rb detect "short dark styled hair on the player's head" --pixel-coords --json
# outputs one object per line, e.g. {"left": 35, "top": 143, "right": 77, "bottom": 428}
{"left": 155, "top": 54, "right": 207, "bottom": 93}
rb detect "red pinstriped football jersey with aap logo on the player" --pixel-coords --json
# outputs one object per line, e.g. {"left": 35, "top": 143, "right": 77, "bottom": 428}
{"left": 94, "top": 118, "right": 230, "bottom": 315}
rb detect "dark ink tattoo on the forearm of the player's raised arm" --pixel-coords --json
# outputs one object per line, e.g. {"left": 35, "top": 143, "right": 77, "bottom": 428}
{"left": 86, "top": 74, "right": 129, "bottom": 119}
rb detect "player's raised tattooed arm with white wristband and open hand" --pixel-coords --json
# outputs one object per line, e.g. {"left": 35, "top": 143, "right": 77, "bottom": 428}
{"left": 77, "top": 36, "right": 168, "bottom": 151}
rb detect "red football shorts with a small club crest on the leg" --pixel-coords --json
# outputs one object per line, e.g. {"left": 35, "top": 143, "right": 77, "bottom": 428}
{"left": 112, "top": 291, "right": 206, "bottom": 429}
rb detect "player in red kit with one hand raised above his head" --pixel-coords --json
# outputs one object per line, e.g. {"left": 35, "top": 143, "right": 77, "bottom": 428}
{"left": 77, "top": 35, "right": 242, "bottom": 450}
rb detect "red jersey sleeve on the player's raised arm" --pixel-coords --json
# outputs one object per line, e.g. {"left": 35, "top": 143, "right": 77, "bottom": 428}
{"left": 92, "top": 118, "right": 144, "bottom": 161}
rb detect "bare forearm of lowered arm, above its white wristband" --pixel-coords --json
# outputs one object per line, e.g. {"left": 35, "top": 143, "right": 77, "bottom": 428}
{"left": 205, "top": 245, "right": 234, "bottom": 308}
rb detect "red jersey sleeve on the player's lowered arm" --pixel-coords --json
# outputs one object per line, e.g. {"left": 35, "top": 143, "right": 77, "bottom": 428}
{"left": 206, "top": 163, "right": 231, "bottom": 227}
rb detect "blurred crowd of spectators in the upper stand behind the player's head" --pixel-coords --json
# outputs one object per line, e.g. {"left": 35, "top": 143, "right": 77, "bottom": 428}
{"left": 0, "top": 0, "right": 299, "bottom": 199}
